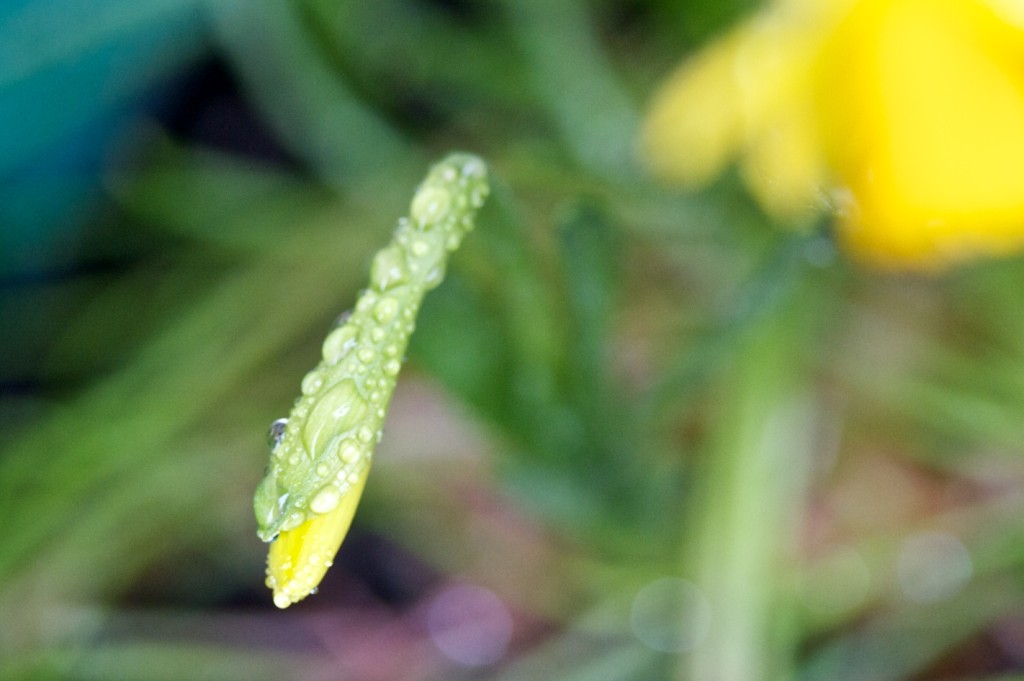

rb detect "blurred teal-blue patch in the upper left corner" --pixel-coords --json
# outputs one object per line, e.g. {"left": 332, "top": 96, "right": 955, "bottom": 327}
{"left": 0, "top": 0, "right": 206, "bottom": 278}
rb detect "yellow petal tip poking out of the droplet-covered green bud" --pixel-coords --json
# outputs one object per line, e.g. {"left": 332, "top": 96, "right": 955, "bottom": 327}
{"left": 266, "top": 466, "right": 370, "bottom": 608}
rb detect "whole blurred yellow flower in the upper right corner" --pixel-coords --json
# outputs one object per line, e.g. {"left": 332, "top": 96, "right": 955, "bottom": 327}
{"left": 643, "top": 0, "right": 1024, "bottom": 268}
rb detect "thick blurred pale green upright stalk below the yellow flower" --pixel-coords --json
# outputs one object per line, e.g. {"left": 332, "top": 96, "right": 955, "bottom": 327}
{"left": 678, "top": 266, "right": 821, "bottom": 681}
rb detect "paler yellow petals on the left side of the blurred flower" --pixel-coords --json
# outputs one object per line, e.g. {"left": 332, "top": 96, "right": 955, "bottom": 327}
{"left": 643, "top": 9, "right": 834, "bottom": 220}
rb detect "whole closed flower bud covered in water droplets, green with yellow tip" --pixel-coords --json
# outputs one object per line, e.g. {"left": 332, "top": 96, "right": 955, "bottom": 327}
{"left": 254, "top": 154, "right": 488, "bottom": 607}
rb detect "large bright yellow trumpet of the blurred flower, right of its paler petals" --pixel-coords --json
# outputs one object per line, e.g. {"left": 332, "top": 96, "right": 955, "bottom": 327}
{"left": 820, "top": 0, "right": 1024, "bottom": 267}
